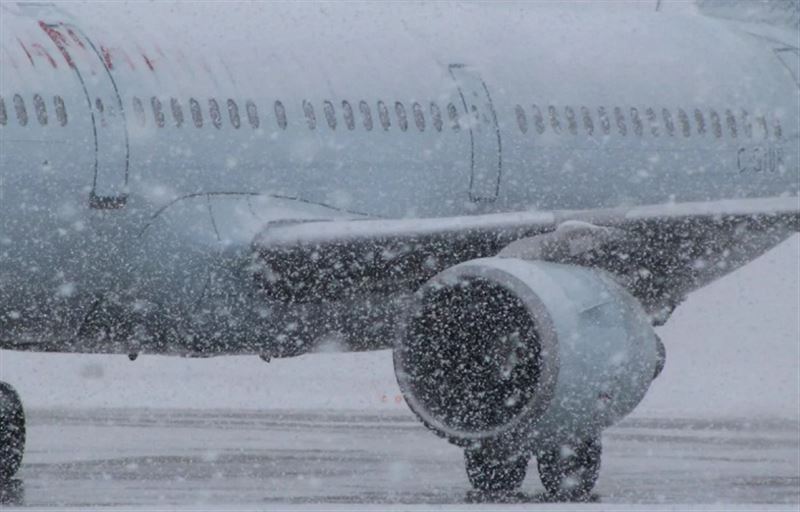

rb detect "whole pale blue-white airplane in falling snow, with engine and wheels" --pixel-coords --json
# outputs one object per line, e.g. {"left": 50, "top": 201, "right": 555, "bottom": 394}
{"left": 0, "top": 2, "right": 800, "bottom": 500}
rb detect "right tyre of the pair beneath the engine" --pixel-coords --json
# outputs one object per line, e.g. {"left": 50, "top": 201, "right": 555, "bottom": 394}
{"left": 536, "top": 438, "right": 602, "bottom": 501}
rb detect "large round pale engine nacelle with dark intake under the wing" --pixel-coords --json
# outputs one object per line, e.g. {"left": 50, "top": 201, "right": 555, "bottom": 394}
{"left": 394, "top": 257, "right": 663, "bottom": 449}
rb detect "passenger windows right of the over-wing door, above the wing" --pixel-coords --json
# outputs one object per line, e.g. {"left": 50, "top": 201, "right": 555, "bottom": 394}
{"left": 514, "top": 105, "right": 783, "bottom": 139}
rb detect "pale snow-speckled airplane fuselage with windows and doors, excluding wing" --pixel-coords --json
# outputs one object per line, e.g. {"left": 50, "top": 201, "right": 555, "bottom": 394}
{"left": 0, "top": 4, "right": 800, "bottom": 353}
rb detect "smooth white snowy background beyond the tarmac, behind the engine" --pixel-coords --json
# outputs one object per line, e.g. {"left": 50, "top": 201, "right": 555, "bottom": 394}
{"left": 0, "top": 236, "right": 800, "bottom": 420}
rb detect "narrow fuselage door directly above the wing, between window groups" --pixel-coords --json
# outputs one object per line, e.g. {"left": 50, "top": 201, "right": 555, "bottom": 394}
{"left": 449, "top": 64, "right": 503, "bottom": 202}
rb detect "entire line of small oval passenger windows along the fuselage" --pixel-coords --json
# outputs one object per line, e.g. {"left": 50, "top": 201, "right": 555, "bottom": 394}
{"left": 0, "top": 94, "right": 783, "bottom": 139}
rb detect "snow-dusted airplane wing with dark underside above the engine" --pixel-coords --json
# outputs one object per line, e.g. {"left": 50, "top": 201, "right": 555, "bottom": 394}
{"left": 254, "top": 197, "right": 800, "bottom": 330}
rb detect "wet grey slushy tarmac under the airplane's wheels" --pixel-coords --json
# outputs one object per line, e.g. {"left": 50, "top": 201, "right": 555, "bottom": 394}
{"left": 3, "top": 409, "right": 800, "bottom": 509}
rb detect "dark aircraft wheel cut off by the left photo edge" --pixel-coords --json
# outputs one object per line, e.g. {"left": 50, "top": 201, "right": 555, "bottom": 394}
{"left": 0, "top": 382, "right": 25, "bottom": 482}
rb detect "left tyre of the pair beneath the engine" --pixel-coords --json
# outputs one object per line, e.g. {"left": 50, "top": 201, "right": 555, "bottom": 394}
{"left": 464, "top": 446, "right": 528, "bottom": 492}
